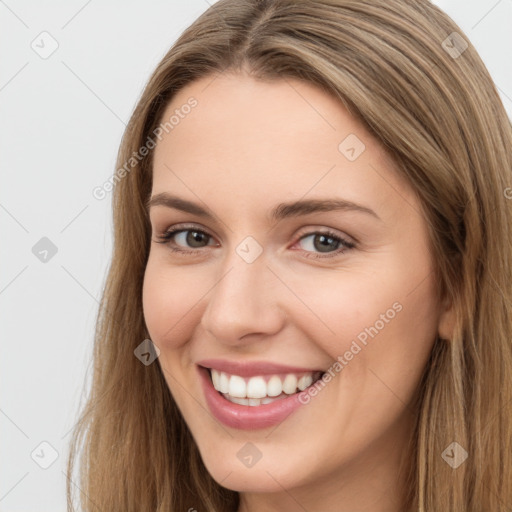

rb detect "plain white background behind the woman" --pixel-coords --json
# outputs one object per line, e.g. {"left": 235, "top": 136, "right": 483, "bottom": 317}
{"left": 0, "top": 0, "right": 512, "bottom": 512}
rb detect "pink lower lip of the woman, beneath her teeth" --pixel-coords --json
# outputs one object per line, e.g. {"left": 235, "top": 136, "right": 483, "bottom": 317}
{"left": 198, "top": 366, "right": 310, "bottom": 430}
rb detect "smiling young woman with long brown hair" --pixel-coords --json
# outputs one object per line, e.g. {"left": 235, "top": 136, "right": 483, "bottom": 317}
{"left": 68, "top": 0, "right": 512, "bottom": 512}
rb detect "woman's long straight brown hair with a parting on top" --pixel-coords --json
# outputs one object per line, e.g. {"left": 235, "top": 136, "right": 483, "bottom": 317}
{"left": 67, "top": 0, "right": 512, "bottom": 512}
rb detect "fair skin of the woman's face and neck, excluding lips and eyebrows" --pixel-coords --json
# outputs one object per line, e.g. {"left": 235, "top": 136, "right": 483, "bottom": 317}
{"left": 143, "top": 72, "right": 453, "bottom": 512}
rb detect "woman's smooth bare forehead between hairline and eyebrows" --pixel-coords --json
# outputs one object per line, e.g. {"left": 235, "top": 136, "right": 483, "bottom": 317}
{"left": 153, "top": 74, "right": 412, "bottom": 224}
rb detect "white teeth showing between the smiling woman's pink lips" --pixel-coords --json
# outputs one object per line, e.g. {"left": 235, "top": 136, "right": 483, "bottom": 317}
{"left": 207, "top": 368, "right": 325, "bottom": 407}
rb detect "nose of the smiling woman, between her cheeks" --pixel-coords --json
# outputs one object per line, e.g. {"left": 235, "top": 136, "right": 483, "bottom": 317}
{"left": 201, "top": 249, "right": 286, "bottom": 346}
